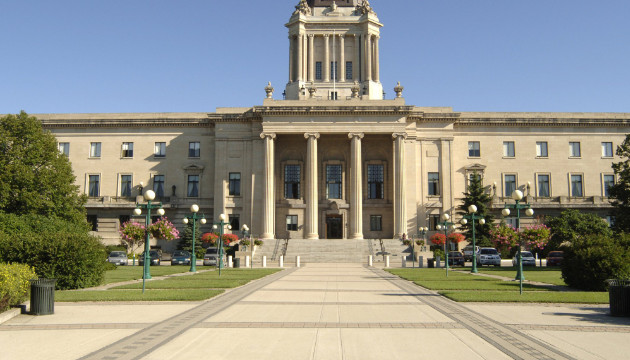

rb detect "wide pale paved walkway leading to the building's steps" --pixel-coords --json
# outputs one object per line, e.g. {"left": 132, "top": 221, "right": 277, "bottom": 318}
{"left": 0, "top": 264, "right": 630, "bottom": 360}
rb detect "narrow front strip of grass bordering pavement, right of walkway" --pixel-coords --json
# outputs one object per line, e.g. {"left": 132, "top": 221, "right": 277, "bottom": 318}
{"left": 438, "top": 290, "right": 608, "bottom": 304}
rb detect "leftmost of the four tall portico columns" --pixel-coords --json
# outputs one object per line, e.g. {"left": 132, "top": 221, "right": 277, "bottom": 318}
{"left": 260, "top": 133, "right": 276, "bottom": 240}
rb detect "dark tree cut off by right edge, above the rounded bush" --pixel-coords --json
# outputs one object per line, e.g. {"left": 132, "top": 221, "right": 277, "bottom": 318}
{"left": 608, "top": 135, "right": 630, "bottom": 233}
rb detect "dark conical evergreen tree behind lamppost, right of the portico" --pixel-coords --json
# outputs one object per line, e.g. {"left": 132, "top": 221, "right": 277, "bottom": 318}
{"left": 457, "top": 172, "right": 494, "bottom": 246}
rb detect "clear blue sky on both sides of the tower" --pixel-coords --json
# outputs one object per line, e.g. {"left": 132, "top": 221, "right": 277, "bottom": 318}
{"left": 0, "top": 0, "right": 630, "bottom": 113}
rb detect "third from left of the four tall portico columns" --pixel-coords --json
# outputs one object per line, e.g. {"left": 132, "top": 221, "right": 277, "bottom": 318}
{"left": 348, "top": 133, "right": 363, "bottom": 239}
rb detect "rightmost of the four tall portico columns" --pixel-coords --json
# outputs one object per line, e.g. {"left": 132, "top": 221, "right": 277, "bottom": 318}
{"left": 392, "top": 133, "right": 407, "bottom": 238}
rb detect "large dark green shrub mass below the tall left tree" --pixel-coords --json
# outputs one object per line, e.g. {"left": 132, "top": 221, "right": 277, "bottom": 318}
{"left": 0, "top": 214, "right": 107, "bottom": 289}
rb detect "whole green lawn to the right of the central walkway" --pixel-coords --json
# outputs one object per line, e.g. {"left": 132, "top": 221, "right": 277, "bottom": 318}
{"left": 387, "top": 268, "right": 608, "bottom": 304}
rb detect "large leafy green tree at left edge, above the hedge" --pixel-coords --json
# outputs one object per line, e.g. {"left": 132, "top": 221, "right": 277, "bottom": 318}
{"left": 0, "top": 111, "right": 86, "bottom": 222}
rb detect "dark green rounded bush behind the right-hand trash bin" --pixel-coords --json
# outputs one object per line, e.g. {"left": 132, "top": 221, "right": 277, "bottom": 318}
{"left": 562, "top": 234, "right": 630, "bottom": 291}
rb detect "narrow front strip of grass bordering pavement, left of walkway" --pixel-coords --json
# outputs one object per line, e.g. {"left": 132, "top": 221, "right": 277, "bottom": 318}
{"left": 55, "top": 289, "right": 223, "bottom": 302}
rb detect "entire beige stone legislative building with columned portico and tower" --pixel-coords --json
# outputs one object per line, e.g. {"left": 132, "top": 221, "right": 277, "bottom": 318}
{"left": 35, "top": 0, "right": 630, "bottom": 252}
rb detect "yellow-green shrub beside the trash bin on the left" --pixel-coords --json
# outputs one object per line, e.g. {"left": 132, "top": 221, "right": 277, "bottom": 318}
{"left": 0, "top": 263, "right": 37, "bottom": 312}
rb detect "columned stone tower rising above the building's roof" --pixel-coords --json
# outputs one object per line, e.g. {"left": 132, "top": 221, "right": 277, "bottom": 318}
{"left": 286, "top": 0, "right": 383, "bottom": 100}
